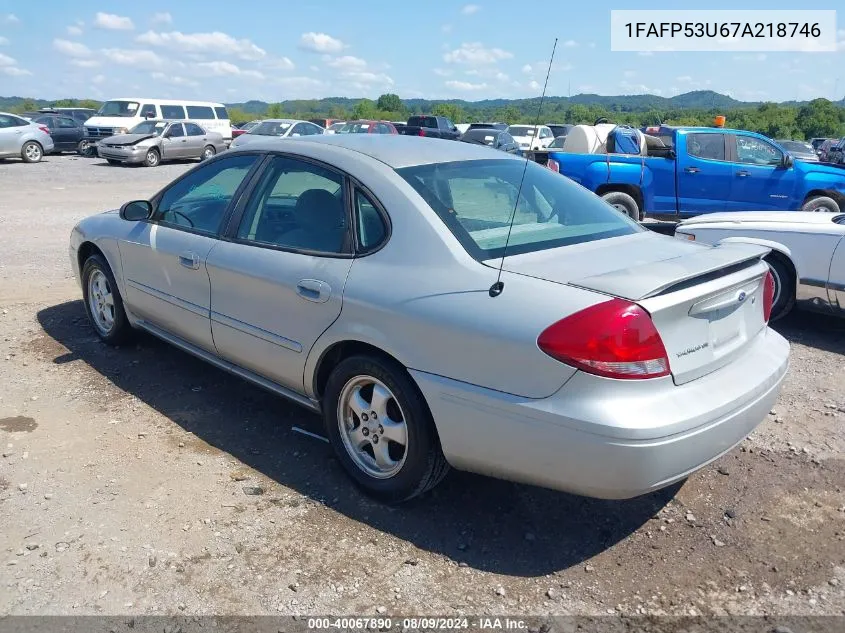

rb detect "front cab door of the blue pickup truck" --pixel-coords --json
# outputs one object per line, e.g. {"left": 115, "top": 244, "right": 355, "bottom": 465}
{"left": 726, "top": 134, "right": 796, "bottom": 211}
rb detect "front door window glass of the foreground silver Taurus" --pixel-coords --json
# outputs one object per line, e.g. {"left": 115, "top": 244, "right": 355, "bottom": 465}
{"left": 155, "top": 154, "right": 257, "bottom": 234}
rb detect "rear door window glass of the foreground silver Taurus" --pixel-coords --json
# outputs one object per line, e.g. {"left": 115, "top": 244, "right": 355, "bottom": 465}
{"left": 238, "top": 157, "right": 350, "bottom": 254}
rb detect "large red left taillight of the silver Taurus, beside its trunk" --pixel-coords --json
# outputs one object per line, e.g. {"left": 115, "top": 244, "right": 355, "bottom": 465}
{"left": 537, "top": 299, "right": 669, "bottom": 379}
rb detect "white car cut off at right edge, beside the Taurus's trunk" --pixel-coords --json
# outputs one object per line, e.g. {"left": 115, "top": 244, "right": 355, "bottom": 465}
{"left": 675, "top": 211, "right": 845, "bottom": 320}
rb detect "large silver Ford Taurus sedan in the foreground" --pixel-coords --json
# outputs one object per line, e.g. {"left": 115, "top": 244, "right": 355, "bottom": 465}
{"left": 70, "top": 134, "right": 789, "bottom": 502}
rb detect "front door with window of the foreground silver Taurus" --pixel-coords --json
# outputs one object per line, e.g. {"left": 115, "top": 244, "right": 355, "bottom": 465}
{"left": 119, "top": 154, "right": 259, "bottom": 351}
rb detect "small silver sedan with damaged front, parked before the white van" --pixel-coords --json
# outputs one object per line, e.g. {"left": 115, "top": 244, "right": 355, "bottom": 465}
{"left": 97, "top": 119, "right": 226, "bottom": 167}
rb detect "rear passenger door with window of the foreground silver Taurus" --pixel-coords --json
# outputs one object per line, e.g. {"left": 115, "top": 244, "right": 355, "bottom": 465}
{"left": 207, "top": 156, "right": 360, "bottom": 392}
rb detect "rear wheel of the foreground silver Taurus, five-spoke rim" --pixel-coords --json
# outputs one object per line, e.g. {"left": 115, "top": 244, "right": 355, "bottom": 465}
{"left": 323, "top": 355, "right": 449, "bottom": 504}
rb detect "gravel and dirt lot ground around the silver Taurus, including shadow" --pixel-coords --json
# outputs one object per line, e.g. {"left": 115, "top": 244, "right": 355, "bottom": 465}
{"left": 0, "top": 156, "right": 845, "bottom": 615}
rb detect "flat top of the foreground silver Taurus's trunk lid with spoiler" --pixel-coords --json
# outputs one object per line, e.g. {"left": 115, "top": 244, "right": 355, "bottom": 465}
{"left": 486, "top": 231, "right": 769, "bottom": 301}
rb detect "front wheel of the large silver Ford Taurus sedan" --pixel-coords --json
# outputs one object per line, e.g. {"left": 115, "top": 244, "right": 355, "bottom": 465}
{"left": 82, "top": 254, "right": 132, "bottom": 345}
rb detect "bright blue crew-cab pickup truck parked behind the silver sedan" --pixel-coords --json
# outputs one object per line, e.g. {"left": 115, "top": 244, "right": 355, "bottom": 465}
{"left": 547, "top": 126, "right": 845, "bottom": 220}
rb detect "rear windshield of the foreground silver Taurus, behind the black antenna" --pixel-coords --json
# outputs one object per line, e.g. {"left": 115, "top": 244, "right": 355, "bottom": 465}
{"left": 397, "top": 159, "right": 646, "bottom": 261}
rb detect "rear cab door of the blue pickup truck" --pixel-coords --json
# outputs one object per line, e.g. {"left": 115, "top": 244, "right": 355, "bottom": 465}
{"left": 676, "top": 132, "right": 734, "bottom": 215}
